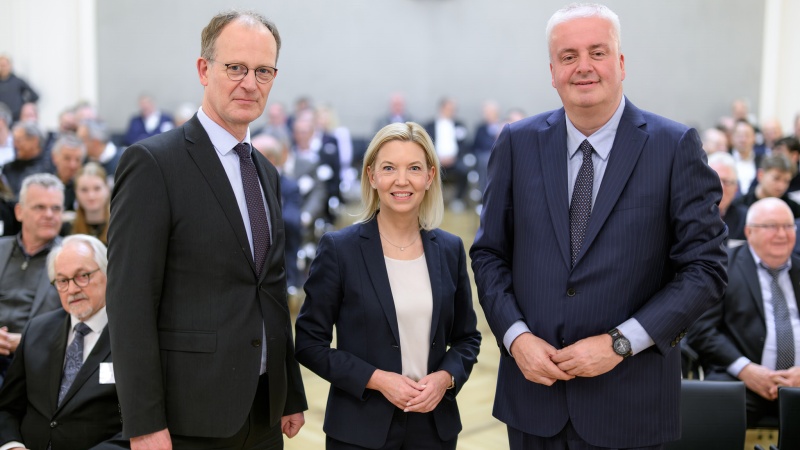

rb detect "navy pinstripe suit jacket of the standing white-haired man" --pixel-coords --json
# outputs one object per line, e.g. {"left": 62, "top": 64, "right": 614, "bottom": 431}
{"left": 471, "top": 101, "right": 727, "bottom": 448}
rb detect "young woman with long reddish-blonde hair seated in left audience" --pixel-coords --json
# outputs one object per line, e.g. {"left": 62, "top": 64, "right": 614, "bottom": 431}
{"left": 69, "top": 162, "right": 111, "bottom": 245}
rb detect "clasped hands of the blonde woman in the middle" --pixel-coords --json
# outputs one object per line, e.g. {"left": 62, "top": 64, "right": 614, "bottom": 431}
{"left": 367, "top": 369, "right": 450, "bottom": 413}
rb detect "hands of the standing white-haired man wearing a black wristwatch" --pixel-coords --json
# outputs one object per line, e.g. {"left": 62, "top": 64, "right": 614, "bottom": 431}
{"left": 511, "top": 333, "right": 623, "bottom": 386}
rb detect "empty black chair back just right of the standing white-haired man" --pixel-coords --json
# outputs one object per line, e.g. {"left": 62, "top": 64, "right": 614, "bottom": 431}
{"left": 667, "top": 380, "right": 747, "bottom": 450}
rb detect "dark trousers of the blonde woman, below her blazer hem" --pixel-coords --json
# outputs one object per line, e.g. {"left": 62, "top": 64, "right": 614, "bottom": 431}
{"left": 325, "top": 408, "right": 458, "bottom": 450}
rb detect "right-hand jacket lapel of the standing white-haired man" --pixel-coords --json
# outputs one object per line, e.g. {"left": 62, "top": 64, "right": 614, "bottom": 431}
{"left": 575, "top": 99, "right": 649, "bottom": 265}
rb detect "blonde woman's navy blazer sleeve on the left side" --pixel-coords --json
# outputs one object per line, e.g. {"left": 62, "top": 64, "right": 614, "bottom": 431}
{"left": 295, "top": 234, "right": 377, "bottom": 398}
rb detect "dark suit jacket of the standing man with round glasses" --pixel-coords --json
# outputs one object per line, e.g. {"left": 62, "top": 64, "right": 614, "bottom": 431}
{"left": 108, "top": 116, "right": 306, "bottom": 437}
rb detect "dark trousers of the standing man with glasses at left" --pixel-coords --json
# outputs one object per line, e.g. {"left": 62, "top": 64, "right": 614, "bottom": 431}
{"left": 172, "top": 374, "right": 283, "bottom": 450}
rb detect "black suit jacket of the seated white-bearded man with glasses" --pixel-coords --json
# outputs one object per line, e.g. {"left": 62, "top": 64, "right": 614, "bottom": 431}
{"left": 0, "top": 309, "right": 130, "bottom": 450}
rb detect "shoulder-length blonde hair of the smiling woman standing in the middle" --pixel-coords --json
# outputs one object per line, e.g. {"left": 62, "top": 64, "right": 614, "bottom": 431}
{"left": 358, "top": 122, "right": 444, "bottom": 230}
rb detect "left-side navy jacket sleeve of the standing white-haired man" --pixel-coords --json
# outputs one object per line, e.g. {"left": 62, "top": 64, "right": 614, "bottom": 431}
{"left": 470, "top": 125, "right": 525, "bottom": 352}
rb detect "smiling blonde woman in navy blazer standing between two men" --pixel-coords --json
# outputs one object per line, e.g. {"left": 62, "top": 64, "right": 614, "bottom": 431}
{"left": 296, "top": 122, "right": 481, "bottom": 449}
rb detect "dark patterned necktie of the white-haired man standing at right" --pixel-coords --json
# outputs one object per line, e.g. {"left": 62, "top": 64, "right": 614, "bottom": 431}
{"left": 569, "top": 140, "right": 594, "bottom": 266}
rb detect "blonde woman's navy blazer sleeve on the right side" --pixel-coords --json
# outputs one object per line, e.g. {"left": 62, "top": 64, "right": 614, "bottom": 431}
{"left": 439, "top": 238, "right": 481, "bottom": 394}
